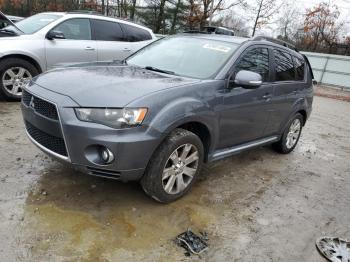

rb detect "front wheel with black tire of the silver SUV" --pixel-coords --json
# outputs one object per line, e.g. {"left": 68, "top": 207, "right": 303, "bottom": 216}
{"left": 0, "top": 58, "right": 39, "bottom": 101}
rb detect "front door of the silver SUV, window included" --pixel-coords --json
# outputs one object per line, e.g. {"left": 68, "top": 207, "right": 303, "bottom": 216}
{"left": 45, "top": 18, "right": 97, "bottom": 69}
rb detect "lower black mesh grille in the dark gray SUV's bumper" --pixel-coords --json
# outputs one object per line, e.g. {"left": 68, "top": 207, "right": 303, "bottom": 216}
{"left": 25, "top": 121, "right": 68, "bottom": 157}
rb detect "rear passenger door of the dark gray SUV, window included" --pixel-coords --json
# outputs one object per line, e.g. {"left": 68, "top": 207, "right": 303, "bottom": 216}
{"left": 266, "top": 48, "right": 305, "bottom": 134}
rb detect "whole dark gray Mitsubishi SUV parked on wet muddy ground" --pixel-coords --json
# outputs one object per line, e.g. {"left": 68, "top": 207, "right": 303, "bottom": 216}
{"left": 21, "top": 34, "right": 313, "bottom": 203}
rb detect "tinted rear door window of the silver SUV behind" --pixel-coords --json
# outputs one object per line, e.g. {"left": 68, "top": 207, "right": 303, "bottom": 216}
{"left": 92, "top": 19, "right": 125, "bottom": 41}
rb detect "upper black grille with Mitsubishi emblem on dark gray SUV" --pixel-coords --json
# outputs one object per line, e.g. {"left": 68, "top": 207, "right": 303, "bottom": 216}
{"left": 22, "top": 90, "right": 58, "bottom": 120}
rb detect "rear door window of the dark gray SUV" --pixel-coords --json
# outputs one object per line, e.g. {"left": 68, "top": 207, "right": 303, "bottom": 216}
{"left": 273, "top": 49, "right": 295, "bottom": 81}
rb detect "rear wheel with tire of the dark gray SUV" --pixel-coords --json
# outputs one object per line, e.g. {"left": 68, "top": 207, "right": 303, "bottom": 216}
{"left": 273, "top": 113, "right": 304, "bottom": 154}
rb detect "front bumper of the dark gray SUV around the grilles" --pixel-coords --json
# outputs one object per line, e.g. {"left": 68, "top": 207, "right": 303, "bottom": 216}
{"left": 21, "top": 85, "right": 162, "bottom": 181}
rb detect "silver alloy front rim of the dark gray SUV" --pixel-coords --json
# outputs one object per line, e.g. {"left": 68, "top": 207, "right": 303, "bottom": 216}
{"left": 162, "top": 144, "right": 199, "bottom": 195}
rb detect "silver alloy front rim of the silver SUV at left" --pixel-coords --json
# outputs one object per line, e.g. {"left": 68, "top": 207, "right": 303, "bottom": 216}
{"left": 2, "top": 67, "right": 32, "bottom": 97}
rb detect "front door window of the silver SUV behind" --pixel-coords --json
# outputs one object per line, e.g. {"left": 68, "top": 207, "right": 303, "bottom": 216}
{"left": 53, "top": 18, "right": 91, "bottom": 40}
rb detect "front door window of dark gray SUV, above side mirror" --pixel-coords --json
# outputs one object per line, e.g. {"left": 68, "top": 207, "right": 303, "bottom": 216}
{"left": 235, "top": 47, "right": 269, "bottom": 82}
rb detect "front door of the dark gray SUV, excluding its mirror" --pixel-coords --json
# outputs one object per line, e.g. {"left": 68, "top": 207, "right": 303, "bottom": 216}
{"left": 219, "top": 46, "right": 274, "bottom": 148}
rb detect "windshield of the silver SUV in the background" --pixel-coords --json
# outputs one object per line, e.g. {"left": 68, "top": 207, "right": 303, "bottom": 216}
{"left": 5, "top": 14, "right": 62, "bottom": 35}
